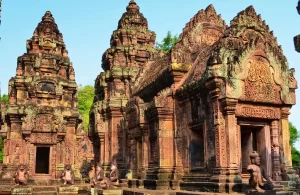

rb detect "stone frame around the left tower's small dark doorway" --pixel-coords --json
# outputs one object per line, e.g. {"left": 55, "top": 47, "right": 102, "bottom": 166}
{"left": 29, "top": 144, "right": 55, "bottom": 179}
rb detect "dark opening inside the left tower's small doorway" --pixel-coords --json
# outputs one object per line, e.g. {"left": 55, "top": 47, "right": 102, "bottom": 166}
{"left": 35, "top": 147, "right": 50, "bottom": 174}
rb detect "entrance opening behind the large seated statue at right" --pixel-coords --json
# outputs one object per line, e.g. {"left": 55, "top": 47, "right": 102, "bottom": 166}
{"left": 238, "top": 125, "right": 272, "bottom": 175}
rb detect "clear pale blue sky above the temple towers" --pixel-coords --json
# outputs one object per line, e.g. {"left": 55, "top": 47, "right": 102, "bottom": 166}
{"left": 0, "top": 0, "right": 300, "bottom": 149}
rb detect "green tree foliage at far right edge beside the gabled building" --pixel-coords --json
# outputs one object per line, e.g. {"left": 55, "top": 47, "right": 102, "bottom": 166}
{"left": 290, "top": 123, "right": 300, "bottom": 167}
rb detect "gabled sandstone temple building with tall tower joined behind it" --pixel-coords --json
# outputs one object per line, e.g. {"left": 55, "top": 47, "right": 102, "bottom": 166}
{"left": 89, "top": 1, "right": 297, "bottom": 192}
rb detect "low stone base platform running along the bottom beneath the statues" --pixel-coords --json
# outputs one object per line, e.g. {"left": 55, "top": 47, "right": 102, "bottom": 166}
{"left": 0, "top": 179, "right": 300, "bottom": 195}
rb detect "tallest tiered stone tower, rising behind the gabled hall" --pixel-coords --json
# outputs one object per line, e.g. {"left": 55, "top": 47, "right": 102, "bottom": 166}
{"left": 89, "top": 0, "right": 156, "bottom": 175}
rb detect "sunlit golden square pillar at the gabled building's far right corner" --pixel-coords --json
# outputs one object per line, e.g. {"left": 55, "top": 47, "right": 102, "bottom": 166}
{"left": 280, "top": 107, "right": 298, "bottom": 181}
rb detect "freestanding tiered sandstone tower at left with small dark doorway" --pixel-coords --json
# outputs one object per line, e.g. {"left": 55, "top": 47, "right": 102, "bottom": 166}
{"left": 1, "top": 11, "right": 93, "bottom": 179}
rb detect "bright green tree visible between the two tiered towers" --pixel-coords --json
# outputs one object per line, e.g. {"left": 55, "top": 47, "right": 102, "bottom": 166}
{"left": 78, "top": 85, "right": 95, "bottom": 131}
